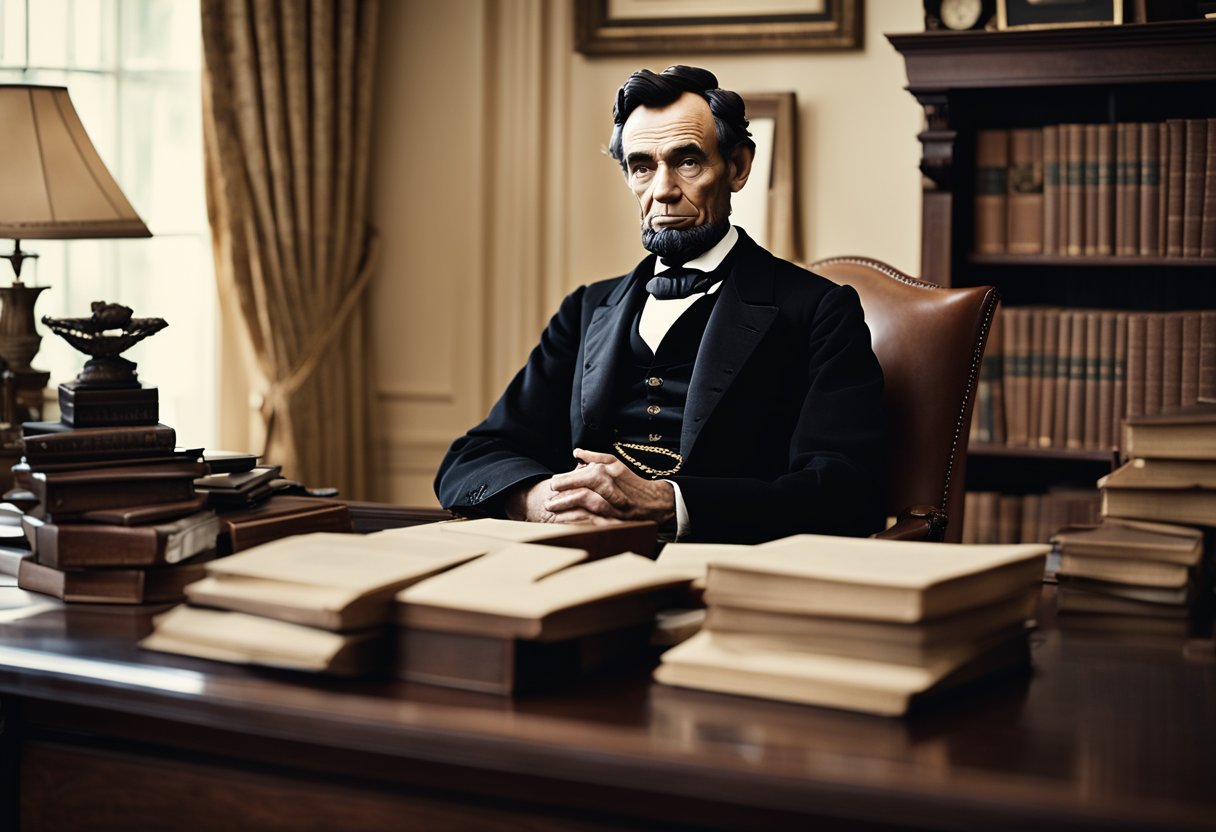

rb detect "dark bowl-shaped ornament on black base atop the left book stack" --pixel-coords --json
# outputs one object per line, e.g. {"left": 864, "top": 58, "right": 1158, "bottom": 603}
{"left": 43, "top": 300, "right": 168, "bottom": 427}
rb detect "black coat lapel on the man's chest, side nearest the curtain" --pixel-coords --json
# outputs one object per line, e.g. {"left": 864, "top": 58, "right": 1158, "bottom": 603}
{"left": 575, "top": 254, "right": 655, "bottom": 435}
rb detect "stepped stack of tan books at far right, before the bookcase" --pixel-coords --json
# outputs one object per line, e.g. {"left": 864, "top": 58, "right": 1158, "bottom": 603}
{"left": 1055, "top": 403, "right": 1216, "bottom": 626}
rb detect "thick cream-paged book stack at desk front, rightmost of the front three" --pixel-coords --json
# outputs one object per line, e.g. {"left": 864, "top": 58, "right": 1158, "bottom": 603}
{"left": 654, "top": 535, "right": 1049, "bottom": 715}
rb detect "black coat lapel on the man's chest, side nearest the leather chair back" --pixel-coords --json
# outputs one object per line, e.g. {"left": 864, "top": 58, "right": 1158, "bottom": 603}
{"left": 680, "top": 229, "right": 777, "bottom": 460}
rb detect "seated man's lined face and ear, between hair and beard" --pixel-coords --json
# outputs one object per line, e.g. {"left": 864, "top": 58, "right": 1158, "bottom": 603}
{"left": 621, "top": 92, "right": 751, "bottom": 257}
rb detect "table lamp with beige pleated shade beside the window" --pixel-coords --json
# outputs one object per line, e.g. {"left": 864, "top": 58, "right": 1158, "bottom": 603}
{"left": 0, "top": 84, "right": 152, "bottom": 425}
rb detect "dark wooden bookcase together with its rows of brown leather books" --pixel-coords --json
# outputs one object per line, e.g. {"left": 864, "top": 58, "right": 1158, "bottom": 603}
{"left": 890, "top": 21, "right": 1216, "bottom": 543}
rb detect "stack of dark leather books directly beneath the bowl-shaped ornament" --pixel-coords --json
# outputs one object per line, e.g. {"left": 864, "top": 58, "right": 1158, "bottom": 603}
{"left": 13, "top": 423, "right": 219, "bottom": 603}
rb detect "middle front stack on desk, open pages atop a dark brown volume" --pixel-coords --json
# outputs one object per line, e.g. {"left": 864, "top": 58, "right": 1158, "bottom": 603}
{"left": 396, "top": 521, "right": 689, "bottom": 695}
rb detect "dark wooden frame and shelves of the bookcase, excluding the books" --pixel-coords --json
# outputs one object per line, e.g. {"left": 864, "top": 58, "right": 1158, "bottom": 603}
{"left": 888, "top": 19, "right": 1216, "bottom": 544}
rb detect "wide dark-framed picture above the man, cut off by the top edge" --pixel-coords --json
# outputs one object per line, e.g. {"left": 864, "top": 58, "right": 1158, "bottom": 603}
{"left": 574, "top": 0, "right": 862, "bottom": 55}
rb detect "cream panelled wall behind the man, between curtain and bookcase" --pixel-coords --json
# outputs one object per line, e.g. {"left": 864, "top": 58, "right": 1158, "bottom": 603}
{"left": 372, "top": 0, "right": 922, "bottom": 505}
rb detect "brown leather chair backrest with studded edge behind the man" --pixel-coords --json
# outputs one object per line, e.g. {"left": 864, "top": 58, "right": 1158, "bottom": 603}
{"left": 809, "top": 257, "right": 1000, "bottom": 543}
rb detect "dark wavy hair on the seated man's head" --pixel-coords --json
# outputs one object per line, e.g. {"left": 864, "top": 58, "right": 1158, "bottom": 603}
{"left": 608, "top": 66, "right": 756, "bottom": 172}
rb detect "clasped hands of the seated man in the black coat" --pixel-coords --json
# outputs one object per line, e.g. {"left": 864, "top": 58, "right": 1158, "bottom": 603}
{"left": 507, "top": 448, "right": 676, "bottom": 524}
